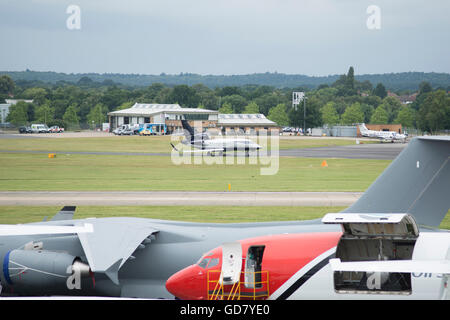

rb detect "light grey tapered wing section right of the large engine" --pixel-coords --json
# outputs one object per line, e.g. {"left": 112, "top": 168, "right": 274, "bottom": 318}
{"left": 74, "top": 219, "right": 158, "bottom": 284}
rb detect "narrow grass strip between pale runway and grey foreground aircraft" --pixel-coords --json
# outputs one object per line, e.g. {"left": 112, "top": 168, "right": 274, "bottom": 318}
{"left": 0, "top": 206, "right": 450, "bottom": 229}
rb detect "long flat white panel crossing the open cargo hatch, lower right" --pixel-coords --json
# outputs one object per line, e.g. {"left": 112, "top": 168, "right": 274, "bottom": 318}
{"left": 330, "top": 258, "right": 450, "bottom": 274}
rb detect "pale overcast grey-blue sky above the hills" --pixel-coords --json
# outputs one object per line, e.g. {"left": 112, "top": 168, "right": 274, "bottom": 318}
{"left": 0, "top": 0, "right": 450, "bottom": 76}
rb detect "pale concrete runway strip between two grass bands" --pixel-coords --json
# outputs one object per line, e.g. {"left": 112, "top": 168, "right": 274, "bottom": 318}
{"left": 0, "top": 191, "right": 362, "bottom": 206}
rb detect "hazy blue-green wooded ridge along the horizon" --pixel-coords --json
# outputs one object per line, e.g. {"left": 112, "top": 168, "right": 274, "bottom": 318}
{"left": 0, "top": 69, "right": 450, "bottom": 91}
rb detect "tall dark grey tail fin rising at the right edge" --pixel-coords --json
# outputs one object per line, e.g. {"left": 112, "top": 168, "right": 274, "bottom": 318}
{"left": 342, "top": 136, "right": 450, "bottom": 227}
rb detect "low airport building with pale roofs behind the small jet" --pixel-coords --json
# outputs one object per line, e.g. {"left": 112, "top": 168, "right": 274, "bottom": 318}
{"left": 108, "top": 103, "right": 279, "bottom": 134}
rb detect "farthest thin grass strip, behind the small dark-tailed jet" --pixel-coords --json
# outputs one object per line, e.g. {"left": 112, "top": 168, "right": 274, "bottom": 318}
{"left": 0, "top": 136, "right": 366, "bottom": 153}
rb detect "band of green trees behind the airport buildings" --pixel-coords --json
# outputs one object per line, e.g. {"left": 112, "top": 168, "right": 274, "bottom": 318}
{"left": 0, "top": 67, "right": 450, "bottom": 133}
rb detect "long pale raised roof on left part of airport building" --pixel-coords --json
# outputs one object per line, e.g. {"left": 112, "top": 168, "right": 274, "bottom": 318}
{"left": 108, "top": 103, "right": 219, "bottom": 116}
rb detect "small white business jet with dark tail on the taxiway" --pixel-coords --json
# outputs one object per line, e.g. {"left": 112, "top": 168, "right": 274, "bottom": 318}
{"left": 171, "top": 120, "right": 261, "bottom": 156}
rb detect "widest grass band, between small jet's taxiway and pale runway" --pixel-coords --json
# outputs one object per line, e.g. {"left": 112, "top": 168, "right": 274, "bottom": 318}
{"left": 0, "top": 152, "right": 390, "bottom": 191}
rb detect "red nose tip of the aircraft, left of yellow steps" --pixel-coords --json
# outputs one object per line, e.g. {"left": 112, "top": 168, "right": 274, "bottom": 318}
{"left": 166, "top": 265, "right": 206, "bottom": 300}
